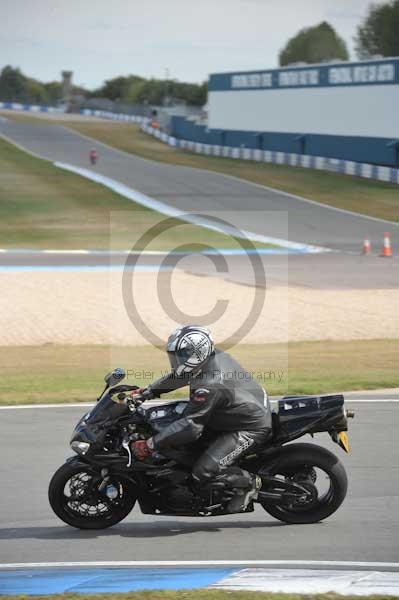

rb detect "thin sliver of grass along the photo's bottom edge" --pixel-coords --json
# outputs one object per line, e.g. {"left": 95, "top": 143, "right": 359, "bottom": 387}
{"left": 2, "top": 590, "right": 398, "bottom": 600}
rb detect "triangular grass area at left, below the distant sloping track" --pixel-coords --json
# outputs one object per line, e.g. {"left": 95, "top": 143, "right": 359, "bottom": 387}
{"left": 0, "top": 138, "right": 272, "bottom": 251}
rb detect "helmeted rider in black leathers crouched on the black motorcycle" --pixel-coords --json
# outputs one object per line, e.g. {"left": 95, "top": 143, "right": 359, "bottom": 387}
{"left": 132, "top": 325, "right": 271, "bottom": 513}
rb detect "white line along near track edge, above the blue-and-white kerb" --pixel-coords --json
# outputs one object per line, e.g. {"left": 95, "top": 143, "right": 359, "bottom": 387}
{"left": 0, "top": 560, "right": 399, "bottom": 569}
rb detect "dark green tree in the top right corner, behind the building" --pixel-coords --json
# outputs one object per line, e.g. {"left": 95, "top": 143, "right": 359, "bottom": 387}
{"left": 355, "top": 0, "right": 399, "bottom": 59}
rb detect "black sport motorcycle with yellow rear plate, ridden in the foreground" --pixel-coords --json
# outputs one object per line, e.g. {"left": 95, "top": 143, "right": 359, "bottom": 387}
{"left": 49, "top": 369, "right": 354, "bottom": 529}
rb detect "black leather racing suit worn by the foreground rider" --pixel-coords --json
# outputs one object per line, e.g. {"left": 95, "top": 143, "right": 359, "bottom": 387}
{"left": 149, "top": 350, "right": 271, "bottom": 487}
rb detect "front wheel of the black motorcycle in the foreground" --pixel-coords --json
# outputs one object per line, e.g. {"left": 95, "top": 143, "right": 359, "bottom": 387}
{"left": 48, "top": 463, "right": 137, "bottom": 529}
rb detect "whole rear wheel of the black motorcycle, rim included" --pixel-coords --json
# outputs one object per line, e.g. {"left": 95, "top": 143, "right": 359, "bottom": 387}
{"left": 259, "top": 444, "right": 348, "bottom": 524}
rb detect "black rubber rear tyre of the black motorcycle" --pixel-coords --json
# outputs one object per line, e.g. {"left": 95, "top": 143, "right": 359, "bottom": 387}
{"left": 259, "top": 444, "right": 348, "bottom": 524}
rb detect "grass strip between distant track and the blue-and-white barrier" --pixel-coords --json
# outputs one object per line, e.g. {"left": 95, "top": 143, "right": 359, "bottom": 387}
{"left": 59, "top": 122, "right": 399, "bottom": 221}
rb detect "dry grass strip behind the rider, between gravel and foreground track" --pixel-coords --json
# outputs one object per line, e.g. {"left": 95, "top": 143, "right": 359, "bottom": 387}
{"left": 0, "top": 340, "right": 399, "bottom": 405}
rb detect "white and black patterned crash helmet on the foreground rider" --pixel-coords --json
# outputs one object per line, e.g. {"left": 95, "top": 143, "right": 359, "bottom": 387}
{"left": 166, "top": 325, "right": 215, "bottom": 375}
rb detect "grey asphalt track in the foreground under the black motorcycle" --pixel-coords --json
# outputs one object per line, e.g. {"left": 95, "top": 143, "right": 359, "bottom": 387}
{"left": 0, "top": 396, "right": 399, "bottom": 563}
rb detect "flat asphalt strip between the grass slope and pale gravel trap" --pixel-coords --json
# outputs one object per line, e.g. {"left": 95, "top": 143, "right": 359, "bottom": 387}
{"left": 0, "top": 250, "right": 399, "bottom": 290}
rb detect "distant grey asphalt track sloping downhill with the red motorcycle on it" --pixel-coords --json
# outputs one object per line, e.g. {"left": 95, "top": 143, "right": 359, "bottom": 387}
{"left": 0, "top": 121, "right": 397, "bottom": 252}
